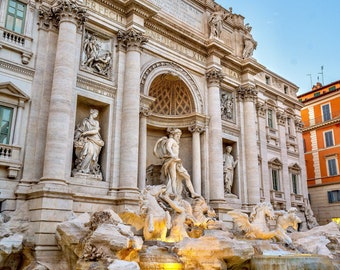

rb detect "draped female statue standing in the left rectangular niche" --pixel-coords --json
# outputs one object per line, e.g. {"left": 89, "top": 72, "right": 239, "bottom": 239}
{"left": 73, "top": 109, "right": 104, "bottom": 179}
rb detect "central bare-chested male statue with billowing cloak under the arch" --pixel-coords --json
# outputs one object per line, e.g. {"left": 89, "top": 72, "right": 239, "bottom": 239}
{"left": 154, "top": 129, "right": 200, "bottom": 198}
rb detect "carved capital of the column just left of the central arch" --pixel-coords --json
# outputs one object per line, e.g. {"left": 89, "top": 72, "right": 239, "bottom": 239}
{"left": 117, "top": 29, "right": 148, "bottom": 51}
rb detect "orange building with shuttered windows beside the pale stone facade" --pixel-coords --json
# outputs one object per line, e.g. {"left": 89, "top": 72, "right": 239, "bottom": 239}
{"left": 298, "top": 81, "right": 340, "bottom": 225}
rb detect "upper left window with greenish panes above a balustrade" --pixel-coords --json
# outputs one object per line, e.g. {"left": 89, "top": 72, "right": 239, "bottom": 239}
{"left": 5, "top": 0, "right": 26, "bottom": 34}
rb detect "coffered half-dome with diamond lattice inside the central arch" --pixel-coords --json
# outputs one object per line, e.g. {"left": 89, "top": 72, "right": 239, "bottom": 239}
{"left": 149, "top": 73, "right": 195, "bottom": 116}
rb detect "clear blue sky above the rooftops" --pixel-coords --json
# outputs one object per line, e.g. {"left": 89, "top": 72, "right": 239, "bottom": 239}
{"left": 216, "top": 0, "right": 340, "bottom": 94}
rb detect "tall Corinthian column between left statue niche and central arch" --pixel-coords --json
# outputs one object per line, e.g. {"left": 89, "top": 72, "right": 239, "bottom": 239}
{"left": 118, "top": 29, "right": 147, "bottom": 192}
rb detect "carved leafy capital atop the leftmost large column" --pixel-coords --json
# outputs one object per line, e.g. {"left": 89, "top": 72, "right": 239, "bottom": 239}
{"left": 51, "top": 0, "right": 87, "bottom": 26}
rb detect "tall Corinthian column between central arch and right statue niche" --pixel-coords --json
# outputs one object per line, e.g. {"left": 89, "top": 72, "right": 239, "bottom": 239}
{"left": 206, "top": 68, "right": 224, "bottom": 202}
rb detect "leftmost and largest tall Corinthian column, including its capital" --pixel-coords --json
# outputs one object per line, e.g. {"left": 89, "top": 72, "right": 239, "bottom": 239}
{"left": 41, "top": 0, "right": 86, "bottom": 183}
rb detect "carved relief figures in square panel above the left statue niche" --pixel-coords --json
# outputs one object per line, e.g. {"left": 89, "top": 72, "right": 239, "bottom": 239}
{"left": 82, "top": 32, "right": 112, "bottom": 76}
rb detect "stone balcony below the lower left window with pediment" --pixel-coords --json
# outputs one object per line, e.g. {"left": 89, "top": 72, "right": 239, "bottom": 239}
{"left": 0, "top": 144, "right": 21, "bottom": 179}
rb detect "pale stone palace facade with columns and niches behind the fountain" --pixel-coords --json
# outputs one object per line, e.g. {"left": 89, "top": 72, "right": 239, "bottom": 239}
{"left": 0, "top": 0, "right": 308, "bottom": 262}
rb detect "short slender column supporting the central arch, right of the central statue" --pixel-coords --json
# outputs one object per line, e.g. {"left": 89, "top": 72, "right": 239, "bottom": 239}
{"left": 188, "top": 123, "right": 205, "bottom": 194}
